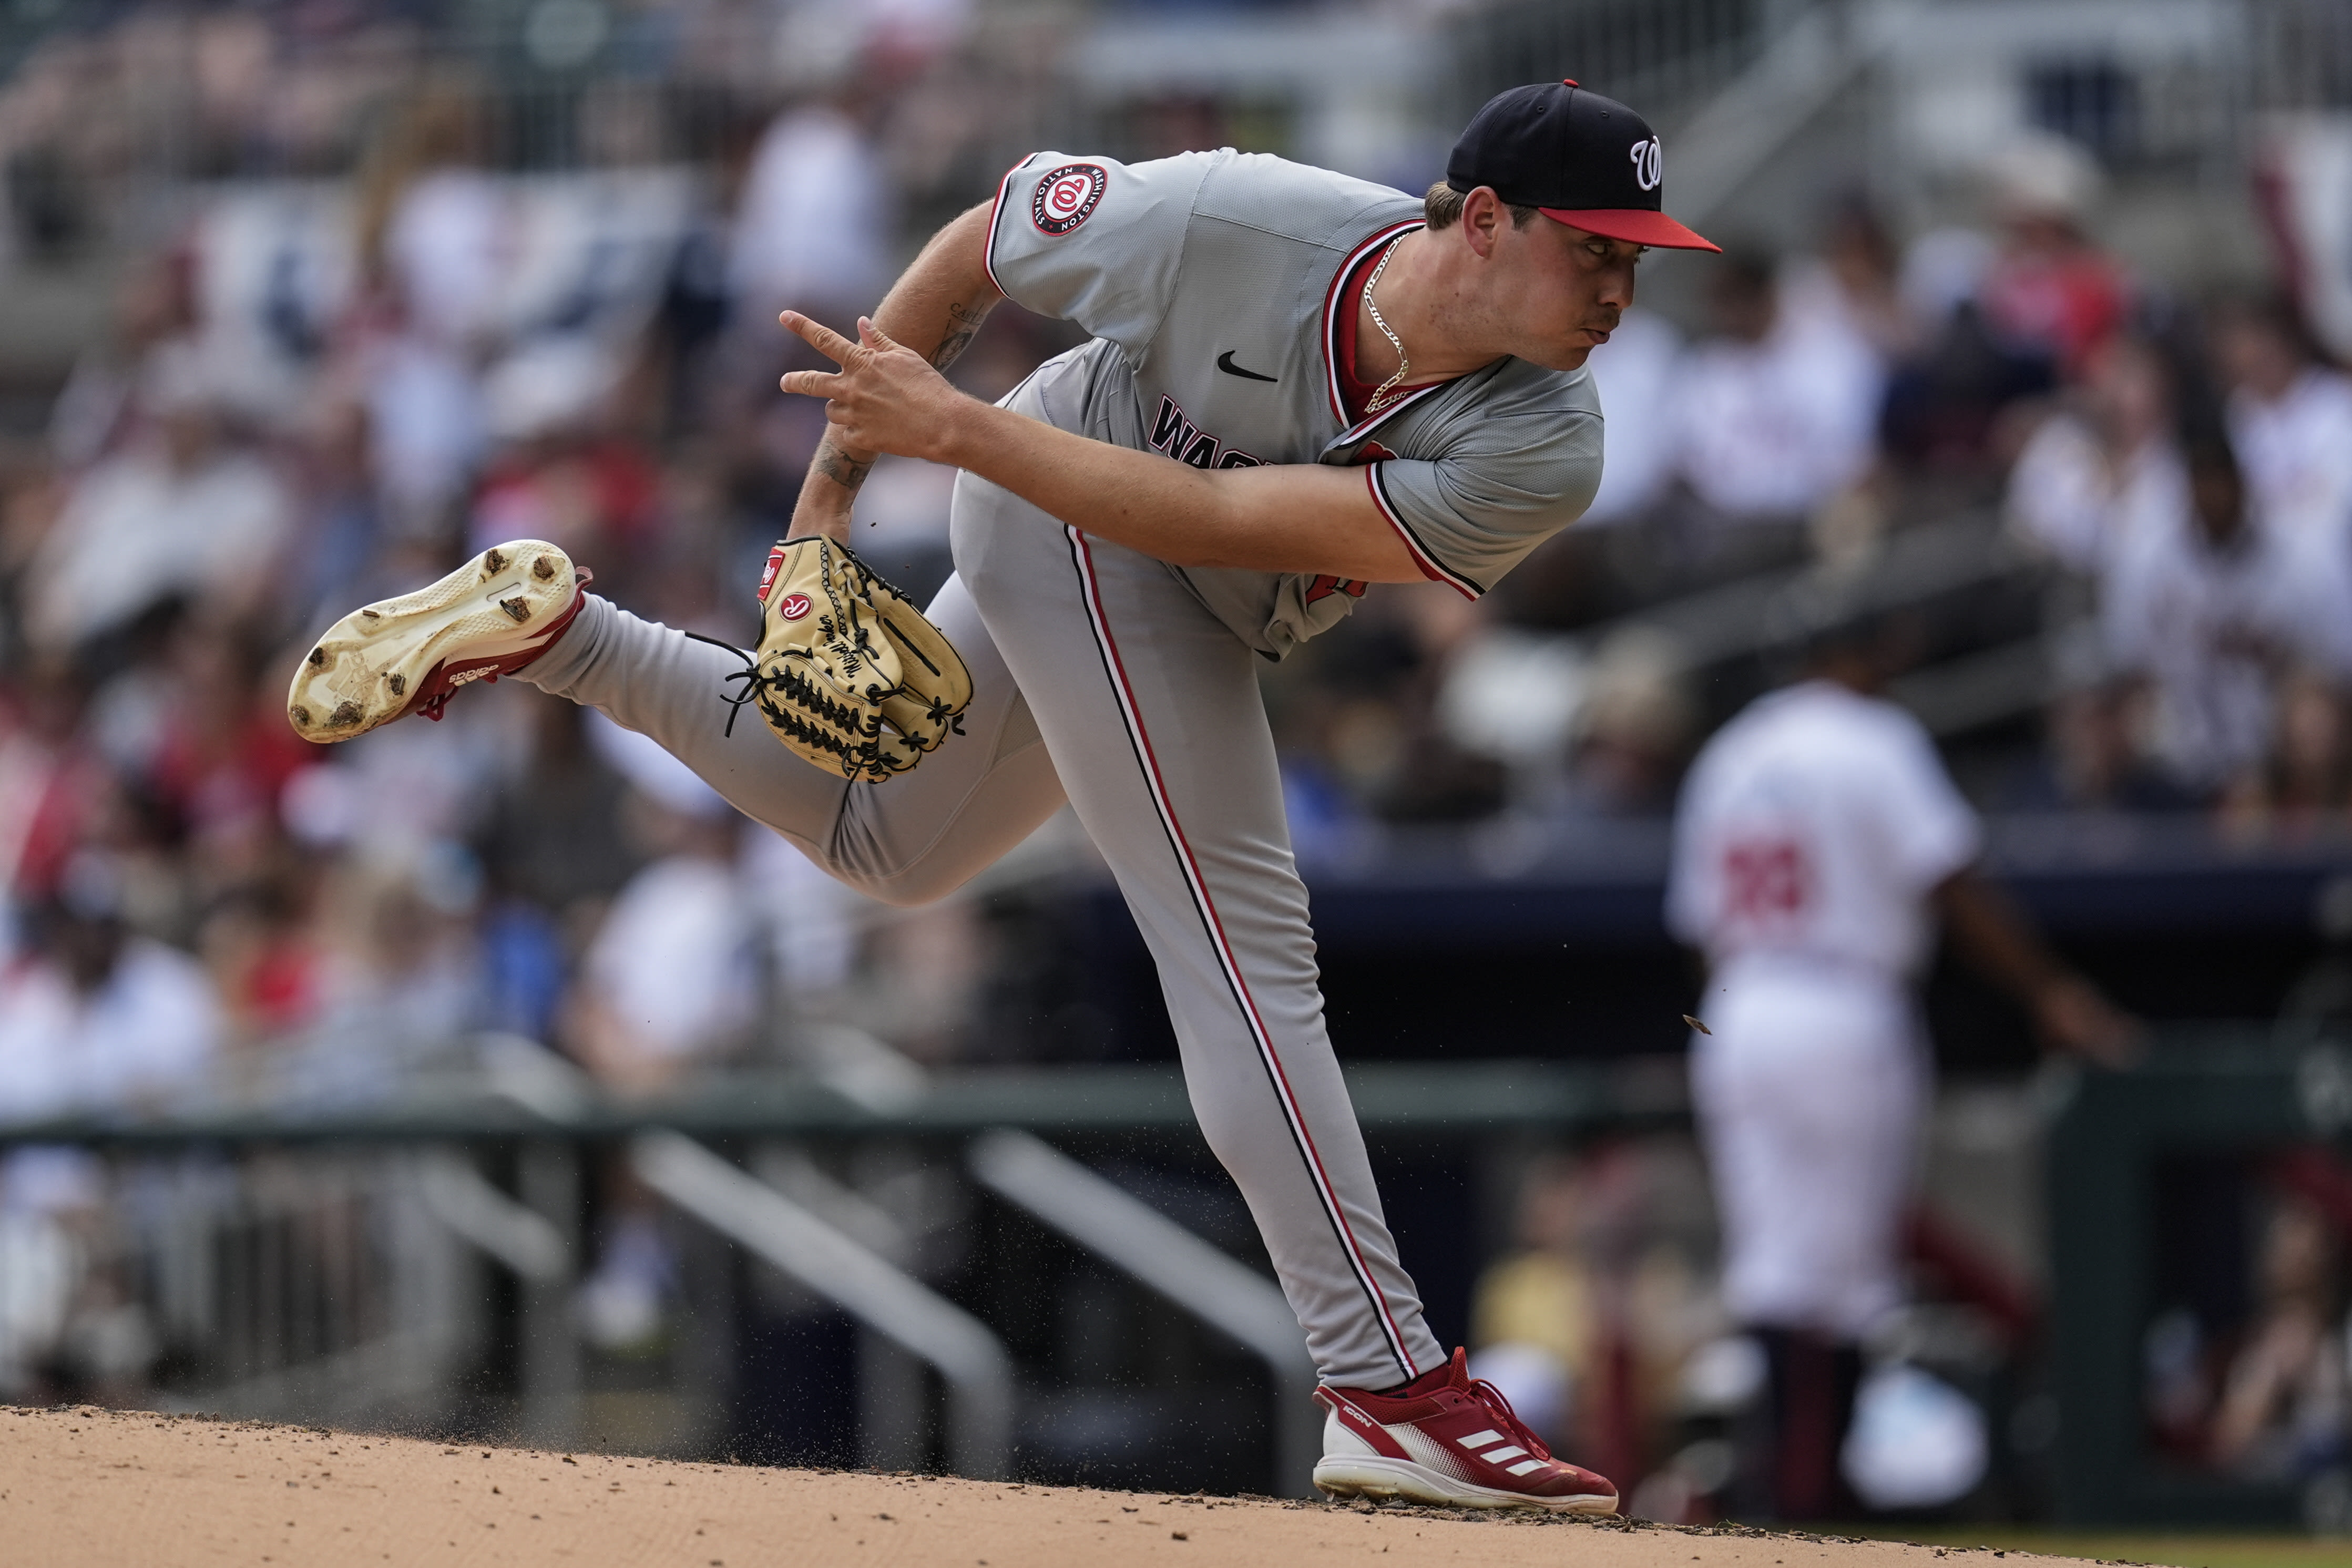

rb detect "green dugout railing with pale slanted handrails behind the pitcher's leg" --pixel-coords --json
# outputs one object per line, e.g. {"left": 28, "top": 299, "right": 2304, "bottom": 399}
{"left": 0, "top": 1039, "right": 1682, "bottom": 1495}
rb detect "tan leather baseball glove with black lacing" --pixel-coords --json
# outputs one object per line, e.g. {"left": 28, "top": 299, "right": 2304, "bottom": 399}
{"left": 734, "top": 538, "right": 972, "bottom": 783}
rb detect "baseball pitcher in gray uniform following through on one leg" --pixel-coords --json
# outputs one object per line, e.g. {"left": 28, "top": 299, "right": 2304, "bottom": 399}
{"left": 289, "top": 83, "right": 1715, "bottom": 1512}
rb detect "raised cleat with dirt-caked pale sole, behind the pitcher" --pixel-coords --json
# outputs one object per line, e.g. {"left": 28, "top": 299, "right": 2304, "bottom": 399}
{"left": 287, "top": 538, "right": 586, "bottom": 743}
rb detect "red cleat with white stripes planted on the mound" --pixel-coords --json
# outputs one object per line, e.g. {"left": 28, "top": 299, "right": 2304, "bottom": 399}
{"left": 1315, "top": 1349, "right": 1616, "bottom": 1514}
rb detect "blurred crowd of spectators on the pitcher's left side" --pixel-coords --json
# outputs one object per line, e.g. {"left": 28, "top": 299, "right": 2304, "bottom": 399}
{"left": 0, "top": 2, "right": 1070, "bottom": 1394}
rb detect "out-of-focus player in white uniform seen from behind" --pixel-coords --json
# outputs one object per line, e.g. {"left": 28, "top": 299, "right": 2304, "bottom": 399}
{"left": 1668, "top": 628, "right": 2133, "bottom": 1519}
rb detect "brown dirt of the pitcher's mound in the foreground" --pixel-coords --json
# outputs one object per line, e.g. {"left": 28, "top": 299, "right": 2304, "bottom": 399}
{"left": 0, "top": 1406, "right": 2098, "bottom": 1568}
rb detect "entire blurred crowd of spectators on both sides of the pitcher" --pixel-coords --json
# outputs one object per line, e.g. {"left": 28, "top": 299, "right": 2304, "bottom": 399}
{"left": 0, "top": 0, "right": 2352, "bottom": 1519}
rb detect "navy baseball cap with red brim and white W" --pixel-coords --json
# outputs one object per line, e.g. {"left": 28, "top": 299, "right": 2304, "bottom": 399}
{"left": 1447, "top": 83, "right": 1724, "bottom": 252}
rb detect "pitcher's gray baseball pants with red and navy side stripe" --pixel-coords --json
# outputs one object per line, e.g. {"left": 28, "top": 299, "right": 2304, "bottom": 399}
{"left": 517, "top": 475, "right": 1444, "bottom": 1389}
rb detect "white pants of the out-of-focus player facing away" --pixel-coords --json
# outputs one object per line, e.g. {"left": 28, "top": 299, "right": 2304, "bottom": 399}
{"left": 1691, "top": 966, "right": 1929, "bottom": 1340}
